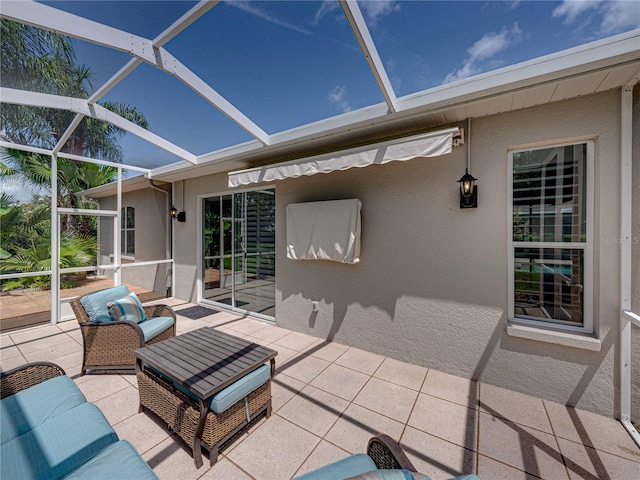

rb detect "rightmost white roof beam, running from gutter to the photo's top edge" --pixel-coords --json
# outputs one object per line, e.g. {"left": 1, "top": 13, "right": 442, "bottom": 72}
{"left": 340, "top": 0, "right": 397, "bottom": 113}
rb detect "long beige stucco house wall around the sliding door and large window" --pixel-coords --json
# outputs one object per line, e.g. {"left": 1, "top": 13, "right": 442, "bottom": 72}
{"left": 174, "top": 90, "right": 640, "bottom": 419}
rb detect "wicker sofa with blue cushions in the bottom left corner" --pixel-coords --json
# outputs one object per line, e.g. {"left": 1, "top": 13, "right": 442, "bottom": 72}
{"left": 0, "top": 362, "right": 158, "bottom": 480}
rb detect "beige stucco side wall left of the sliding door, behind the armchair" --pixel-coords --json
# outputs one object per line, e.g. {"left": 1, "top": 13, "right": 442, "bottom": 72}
{"left": 100, "top": 188, "right": 171, "bottom": 295}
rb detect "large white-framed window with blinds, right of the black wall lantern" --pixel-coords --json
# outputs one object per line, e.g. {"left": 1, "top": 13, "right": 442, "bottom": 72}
{"left": 509, "top": 142, "right": 593, "bottom": 332}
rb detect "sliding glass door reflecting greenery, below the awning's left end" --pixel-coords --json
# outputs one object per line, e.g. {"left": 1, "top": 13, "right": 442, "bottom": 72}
{"left": 202, "top": 189, "right": 276, "bottom": 318}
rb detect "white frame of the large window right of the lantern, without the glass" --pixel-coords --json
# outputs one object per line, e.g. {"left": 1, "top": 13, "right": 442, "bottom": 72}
{"left": 507, "top": 139, "right": 595, "bottom": 334}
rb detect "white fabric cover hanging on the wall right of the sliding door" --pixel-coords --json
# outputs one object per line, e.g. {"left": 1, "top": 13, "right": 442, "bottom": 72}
{"left": 287, "top": 199, "right": 362, "bottom": 263}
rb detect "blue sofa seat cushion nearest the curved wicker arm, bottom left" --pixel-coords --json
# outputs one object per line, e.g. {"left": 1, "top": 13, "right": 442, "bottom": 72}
{"left": 0, "top": 375, "right": 86, "bottom": 444}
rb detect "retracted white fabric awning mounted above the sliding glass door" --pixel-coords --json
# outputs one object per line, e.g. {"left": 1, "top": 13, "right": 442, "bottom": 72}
{"left": 229, "top": 127, "right": 460, "bottom": 187}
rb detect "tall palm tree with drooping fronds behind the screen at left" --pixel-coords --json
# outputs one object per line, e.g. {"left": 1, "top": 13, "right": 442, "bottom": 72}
{"left": 0, "top": 19, "right": 148, "bottom": 233}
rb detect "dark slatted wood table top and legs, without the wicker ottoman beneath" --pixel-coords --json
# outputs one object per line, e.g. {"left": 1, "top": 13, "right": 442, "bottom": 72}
{"left": 135, "top": 327, "right": 278, "bottom": 468}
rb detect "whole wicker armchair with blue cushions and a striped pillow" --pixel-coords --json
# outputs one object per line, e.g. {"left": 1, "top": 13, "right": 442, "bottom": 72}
{"left": 70, "top": 285, "right": 176, "bottom": 375}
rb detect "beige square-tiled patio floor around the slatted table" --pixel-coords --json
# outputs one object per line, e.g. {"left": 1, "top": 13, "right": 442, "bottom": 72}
{"left": 0, "top": 299, "right": 640, "bottom": 480}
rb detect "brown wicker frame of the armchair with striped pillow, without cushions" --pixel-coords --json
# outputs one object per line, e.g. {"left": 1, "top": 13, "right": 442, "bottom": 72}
{"left": 70, "top": 286, "right": 176, "bottom": 375}
